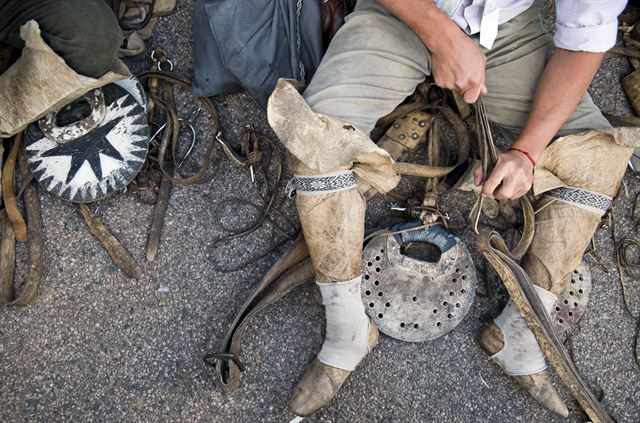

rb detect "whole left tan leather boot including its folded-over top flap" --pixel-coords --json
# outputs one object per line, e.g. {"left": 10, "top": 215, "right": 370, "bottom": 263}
{"left": 267, "top": 79, "right": 399, "bottom": 416}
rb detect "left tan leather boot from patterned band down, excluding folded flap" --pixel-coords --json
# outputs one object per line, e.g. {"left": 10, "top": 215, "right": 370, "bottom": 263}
{"left": 290, "top": 160, "right": 378, "bottom": 416}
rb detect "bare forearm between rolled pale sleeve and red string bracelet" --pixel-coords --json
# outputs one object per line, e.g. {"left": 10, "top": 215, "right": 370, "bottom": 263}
{"left": 513, "top": 49, "right": 604, "bottom": 160}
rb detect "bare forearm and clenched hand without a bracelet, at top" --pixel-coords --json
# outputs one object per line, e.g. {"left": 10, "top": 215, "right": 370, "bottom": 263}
{"left": 378, "top": 0, "right": 487, "bottom": 103}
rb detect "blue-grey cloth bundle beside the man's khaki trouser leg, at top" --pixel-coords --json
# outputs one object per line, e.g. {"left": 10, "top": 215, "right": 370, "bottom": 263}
{"left": 193, "top": 0, "right": 323, "bottom": 109}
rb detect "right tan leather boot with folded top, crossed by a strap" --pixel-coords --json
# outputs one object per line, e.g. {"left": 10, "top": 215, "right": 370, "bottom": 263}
{"left": 480, "top": 131, "right": 633, "bottom": 417}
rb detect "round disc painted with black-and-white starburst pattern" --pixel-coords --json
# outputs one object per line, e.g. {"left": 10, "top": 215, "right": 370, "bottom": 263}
{"left": 25, "top": 82, "right": 149, "bottom": 203}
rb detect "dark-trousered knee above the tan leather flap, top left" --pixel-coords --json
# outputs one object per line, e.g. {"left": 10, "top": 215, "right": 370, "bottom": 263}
{"left": 39, "top": 0, "right": 122, "bottom": 77}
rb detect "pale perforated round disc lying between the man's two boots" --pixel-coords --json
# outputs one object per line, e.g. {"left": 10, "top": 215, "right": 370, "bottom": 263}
{"left": 362, "top": 236, "right": 477, "bottom": 342}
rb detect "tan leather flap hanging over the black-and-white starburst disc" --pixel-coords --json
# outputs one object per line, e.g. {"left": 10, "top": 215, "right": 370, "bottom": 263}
{"left": 0, "top": 21, "right": 125, "bottom": 138}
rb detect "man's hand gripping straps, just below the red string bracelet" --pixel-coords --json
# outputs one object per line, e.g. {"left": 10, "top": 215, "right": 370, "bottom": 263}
{"left": 473, "top": 150, "right": 533, "bottom": 200}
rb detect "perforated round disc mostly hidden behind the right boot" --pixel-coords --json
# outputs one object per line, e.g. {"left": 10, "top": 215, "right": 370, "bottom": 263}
{"left": 551, "top": 260, "right": 592, "bottom": 333}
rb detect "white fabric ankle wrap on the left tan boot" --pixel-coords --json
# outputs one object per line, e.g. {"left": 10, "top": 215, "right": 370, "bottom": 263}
{"left": 318, "top": 276, "right": 369, "bottom": 371}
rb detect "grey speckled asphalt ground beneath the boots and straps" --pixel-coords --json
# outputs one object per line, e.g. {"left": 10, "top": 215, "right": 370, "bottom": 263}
{"left": 0, "top": 1, "right": 640, "bottom": 423}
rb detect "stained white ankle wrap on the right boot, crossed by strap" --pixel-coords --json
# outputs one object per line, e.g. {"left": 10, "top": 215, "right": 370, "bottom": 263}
{"left": 491, "top": 285, "right": 557, "bottom": 376}
